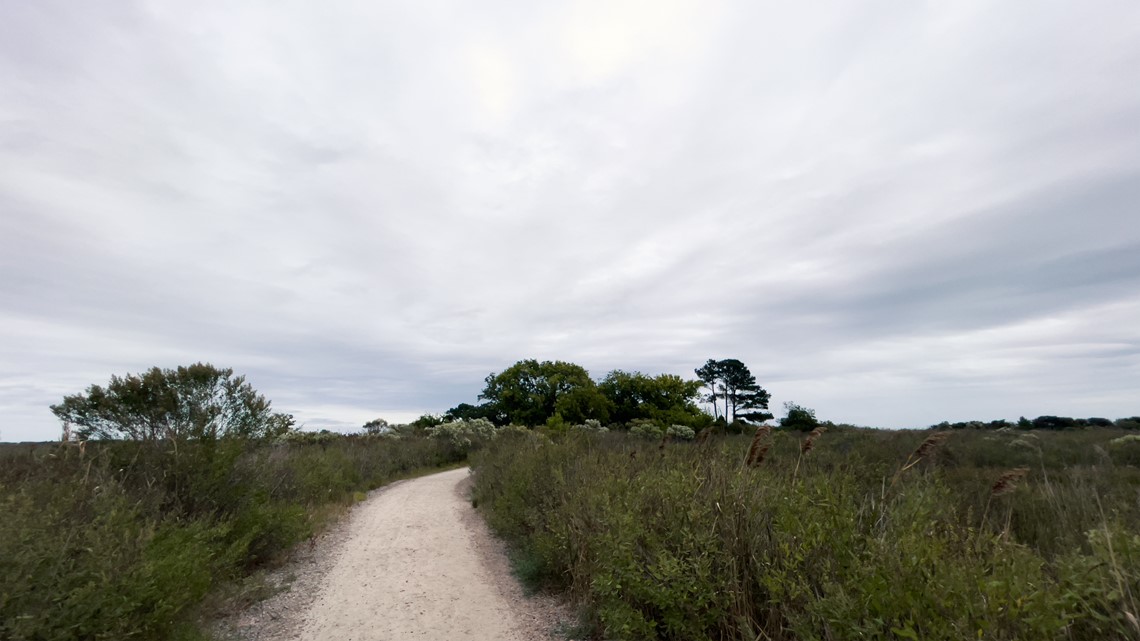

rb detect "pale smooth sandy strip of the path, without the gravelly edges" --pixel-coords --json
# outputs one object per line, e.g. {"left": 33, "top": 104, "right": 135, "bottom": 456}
{"left": 299, "top": 469, "right": 535, "bottom": 641}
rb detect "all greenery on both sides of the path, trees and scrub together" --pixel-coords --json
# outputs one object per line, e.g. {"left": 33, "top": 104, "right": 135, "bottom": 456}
{"left": 8, "top": 359, "right": 1140, "bottom": 641}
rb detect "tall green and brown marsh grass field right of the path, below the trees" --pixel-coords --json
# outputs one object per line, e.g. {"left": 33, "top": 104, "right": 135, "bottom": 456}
{"left": 474, "top": 430, "right": 1140, "bottom": 641}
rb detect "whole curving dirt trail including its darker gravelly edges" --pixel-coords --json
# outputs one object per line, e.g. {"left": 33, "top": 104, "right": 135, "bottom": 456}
{"left": 214, "top": 469, "right": 567, "bottom": 641}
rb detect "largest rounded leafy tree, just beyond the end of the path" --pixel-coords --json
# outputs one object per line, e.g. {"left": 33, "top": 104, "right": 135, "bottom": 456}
{"left": 479, "top": 359, "right": 610, "bottom": 425}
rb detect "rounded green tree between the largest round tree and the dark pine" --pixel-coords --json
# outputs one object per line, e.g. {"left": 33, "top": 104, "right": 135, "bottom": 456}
{"left": 597, "top": 370, "right": 708, "bottom": 427}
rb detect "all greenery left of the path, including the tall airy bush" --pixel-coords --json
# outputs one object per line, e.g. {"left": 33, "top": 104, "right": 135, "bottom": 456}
{"left": 0, "top": 364, "right": 481, "bottom": 641}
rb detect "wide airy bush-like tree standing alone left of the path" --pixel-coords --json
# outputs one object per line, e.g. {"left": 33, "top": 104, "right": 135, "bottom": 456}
{"left": 51, "top": 363, "right": 293, "bottom": 441}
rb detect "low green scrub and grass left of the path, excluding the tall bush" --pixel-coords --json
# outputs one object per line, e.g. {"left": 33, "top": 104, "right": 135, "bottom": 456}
{"left": 0, "top": 436, "right": 465, "bottom": 641}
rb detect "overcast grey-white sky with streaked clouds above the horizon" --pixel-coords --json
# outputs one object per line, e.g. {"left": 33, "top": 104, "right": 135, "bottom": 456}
{"left": 0, "top": 0, "right": 1140, "bottom": 440}
